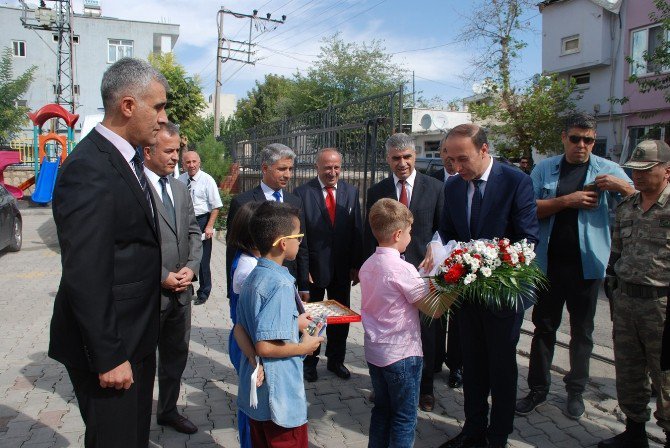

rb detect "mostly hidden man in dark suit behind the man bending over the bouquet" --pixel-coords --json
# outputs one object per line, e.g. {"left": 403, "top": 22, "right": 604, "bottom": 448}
{"left": 433, "top": 135, "right": 463, "bottom": 389}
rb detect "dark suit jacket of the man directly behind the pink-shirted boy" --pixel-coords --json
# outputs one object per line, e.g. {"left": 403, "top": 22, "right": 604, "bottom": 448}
{"left": 364, "top": 171, "right": 444, "bottom": 266}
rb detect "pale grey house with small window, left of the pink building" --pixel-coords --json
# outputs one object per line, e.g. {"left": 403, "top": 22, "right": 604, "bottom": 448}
{"left": 540, "top": 0, "right": 632, "bottom": 158}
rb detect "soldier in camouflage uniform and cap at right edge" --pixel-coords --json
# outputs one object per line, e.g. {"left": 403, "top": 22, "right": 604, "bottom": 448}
{"left": 598, "top": 140, "right": 670, "bottom": 448}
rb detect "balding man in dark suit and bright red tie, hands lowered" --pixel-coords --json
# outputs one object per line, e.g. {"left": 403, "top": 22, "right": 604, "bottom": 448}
{"left": 295, "top": 148, "right": 363, "bottom": 381}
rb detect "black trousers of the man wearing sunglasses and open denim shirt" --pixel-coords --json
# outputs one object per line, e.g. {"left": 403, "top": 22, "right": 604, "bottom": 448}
{"left": 528, "top": 261, "right": 602, "bottom": 393}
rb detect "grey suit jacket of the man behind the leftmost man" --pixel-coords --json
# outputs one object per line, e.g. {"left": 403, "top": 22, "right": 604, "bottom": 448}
{"left": 149, "top": 176, "right": 202, "bottom": 310}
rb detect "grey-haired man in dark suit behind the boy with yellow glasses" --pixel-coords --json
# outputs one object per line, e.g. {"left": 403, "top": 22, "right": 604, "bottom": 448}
{"left": 226, "top": 143, "right": 309, "bottom": 301}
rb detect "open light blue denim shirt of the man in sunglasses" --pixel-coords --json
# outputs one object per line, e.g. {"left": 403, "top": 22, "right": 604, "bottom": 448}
{"left": 530, "top": 154, "right": 633, "bottom": 279}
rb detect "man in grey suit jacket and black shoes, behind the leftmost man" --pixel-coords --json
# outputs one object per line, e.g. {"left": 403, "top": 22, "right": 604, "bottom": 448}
{"left": 144, "top": 123, "right": 202, "bottom": 434}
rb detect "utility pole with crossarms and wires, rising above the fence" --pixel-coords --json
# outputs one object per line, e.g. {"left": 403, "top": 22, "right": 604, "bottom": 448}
{"left": 214, "top": 6, "right": 286, "bottom": 137}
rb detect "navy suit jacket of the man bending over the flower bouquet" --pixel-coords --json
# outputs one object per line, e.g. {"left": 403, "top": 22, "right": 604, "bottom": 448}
{"left": 440, "top": 160, "right": 540, "bottom": 308}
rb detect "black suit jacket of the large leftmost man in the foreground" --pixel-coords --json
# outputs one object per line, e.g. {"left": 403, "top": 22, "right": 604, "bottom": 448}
{"left": 49, "top": 130, "right": 161, "bottom": 373}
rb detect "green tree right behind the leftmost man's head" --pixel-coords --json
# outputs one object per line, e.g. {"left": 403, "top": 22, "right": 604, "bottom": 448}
{"left": 148, "top": 53, "right": 206, "bottom": 141}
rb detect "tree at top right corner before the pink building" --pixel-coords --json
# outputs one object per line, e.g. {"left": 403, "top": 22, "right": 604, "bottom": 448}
{"left": 632, "top": 0, "right": 670, "bottom": 103}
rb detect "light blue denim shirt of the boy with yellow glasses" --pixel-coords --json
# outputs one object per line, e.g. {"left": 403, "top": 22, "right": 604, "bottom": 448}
{"left": 237, "top": 258, "right": 307, "bottom": 428}
